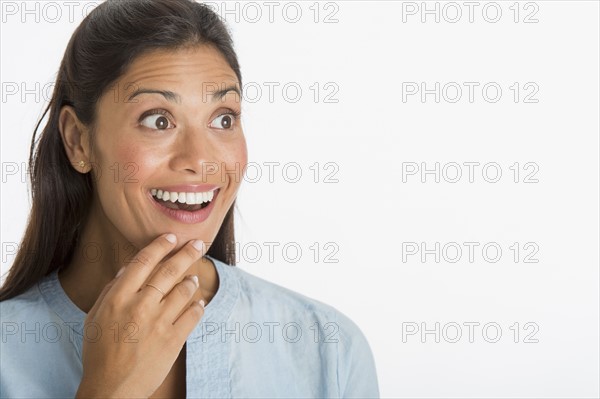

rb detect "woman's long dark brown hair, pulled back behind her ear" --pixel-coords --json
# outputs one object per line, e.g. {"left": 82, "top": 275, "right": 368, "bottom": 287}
{"left": 0, "top": 0, "right": 242, "bottom": 301}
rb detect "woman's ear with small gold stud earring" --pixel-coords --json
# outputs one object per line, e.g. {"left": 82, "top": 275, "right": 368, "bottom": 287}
{"left": 58, "top": 105, "right": 91, "bottom": 173}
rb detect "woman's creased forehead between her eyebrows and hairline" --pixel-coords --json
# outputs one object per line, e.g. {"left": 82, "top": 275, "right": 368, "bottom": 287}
{"left": 118, "top": 45, "right": 239, "bottom": 91}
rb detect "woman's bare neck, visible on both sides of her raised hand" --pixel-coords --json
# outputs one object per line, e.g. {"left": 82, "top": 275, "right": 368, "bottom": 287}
{"left": 58, "top": 198, "right": 219, "bottom": 313}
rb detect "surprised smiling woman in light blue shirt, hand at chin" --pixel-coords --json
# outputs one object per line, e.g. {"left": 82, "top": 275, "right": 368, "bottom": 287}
{"left": 0, "top": 0, "right": 379, "bottom": 398}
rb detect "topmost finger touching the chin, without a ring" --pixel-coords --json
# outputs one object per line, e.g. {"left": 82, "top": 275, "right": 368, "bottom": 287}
{"left": 115, "top": 234, "right": 177, "bottom": 293}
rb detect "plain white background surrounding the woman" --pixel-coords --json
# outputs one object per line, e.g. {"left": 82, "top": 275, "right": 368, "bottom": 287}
{"left": 1, "top": 1, "right": 600, "bottom": 398}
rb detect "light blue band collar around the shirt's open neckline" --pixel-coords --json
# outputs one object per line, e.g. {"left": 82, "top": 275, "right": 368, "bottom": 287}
{"left": 38, "top": 255, "right": 240, "bottom": 340}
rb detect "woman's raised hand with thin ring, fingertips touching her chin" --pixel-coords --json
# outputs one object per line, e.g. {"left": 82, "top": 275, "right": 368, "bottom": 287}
{"left": 76, "top": 235, "right": 206, "bottom": 398}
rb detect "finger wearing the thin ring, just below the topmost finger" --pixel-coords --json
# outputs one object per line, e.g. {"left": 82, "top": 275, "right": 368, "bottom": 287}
{"left": 142, "top": 240, "right": 206, "bottom": 301}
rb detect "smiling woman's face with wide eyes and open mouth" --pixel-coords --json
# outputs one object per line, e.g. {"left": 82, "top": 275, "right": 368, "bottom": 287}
{"left": 90, "top": 46, "right": 247, "bottom": 248}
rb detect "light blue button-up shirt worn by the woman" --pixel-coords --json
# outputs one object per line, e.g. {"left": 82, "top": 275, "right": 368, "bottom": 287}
{"left": 0, "top": 258, "right": 379, "bottom": 398}
